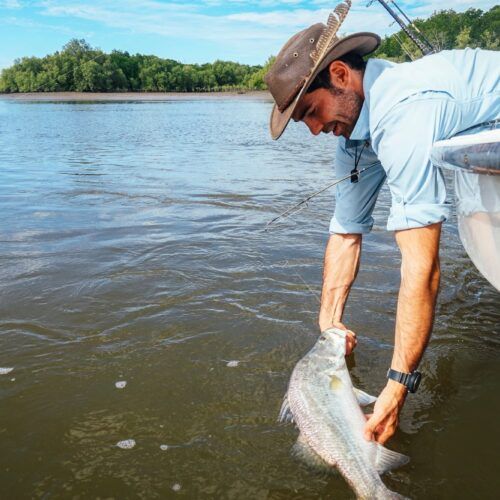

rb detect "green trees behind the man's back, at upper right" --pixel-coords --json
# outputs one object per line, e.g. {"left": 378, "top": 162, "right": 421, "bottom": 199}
{"left": 373, "top": 5, "right": 500, "bottom": 62}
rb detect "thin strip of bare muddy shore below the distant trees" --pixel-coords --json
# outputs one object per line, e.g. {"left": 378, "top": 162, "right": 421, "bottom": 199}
{"left": 0, "top": 90, "right": 272, "bottom": 102}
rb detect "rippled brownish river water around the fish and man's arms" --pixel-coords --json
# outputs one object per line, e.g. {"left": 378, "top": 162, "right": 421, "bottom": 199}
{"left": 0, "top": 98, "right": 500, "bottom": 500}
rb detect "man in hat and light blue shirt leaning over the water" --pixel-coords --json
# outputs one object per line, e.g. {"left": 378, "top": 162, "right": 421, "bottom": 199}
{"left": 266, "top": 0, "right": 500, "bottom": 443}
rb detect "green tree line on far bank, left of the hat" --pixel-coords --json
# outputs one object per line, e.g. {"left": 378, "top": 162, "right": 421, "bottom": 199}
{"left": 0, "top": 39, "right": 272, "bottom": 92}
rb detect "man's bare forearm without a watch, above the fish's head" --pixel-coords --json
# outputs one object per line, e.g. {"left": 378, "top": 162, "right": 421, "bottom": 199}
{"left": 319, "top": 234, "right": 361, "bottom": 331}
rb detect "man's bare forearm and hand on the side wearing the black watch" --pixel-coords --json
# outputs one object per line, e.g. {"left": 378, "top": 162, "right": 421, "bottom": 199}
{"left": 365, "top": 223, "right": 441, "bottom": 443}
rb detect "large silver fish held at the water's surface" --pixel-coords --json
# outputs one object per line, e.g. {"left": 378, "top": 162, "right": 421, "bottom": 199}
{"left": 278, "top": 328, "right": 409, "bottom": 500}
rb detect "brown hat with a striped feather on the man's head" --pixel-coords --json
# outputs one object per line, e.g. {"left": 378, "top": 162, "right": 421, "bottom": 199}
{"left": 264, "top": 0, "right": 380, "bottom": 140}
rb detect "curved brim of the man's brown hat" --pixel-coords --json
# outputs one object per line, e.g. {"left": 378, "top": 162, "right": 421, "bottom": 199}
{"left": 269, "top": 32, "right": 380, "bottom": 140}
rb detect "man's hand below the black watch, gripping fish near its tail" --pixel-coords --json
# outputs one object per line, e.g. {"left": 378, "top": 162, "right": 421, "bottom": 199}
{"left": 365, "top": 380, "right": 407, "bottom": 444}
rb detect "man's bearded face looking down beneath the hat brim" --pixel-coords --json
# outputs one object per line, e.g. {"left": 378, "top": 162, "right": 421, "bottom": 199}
{"left": 292, "top": 84, "right": 363, "bottom": 139}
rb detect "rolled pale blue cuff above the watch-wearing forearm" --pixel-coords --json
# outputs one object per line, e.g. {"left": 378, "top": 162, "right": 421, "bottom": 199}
{"left": 387, "top": 203, "right": 451, "bottom": 231}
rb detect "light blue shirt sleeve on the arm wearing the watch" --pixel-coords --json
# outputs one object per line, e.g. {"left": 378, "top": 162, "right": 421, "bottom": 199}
{"left": 372, "top": 96, "right": 453, "bottom": 231}
